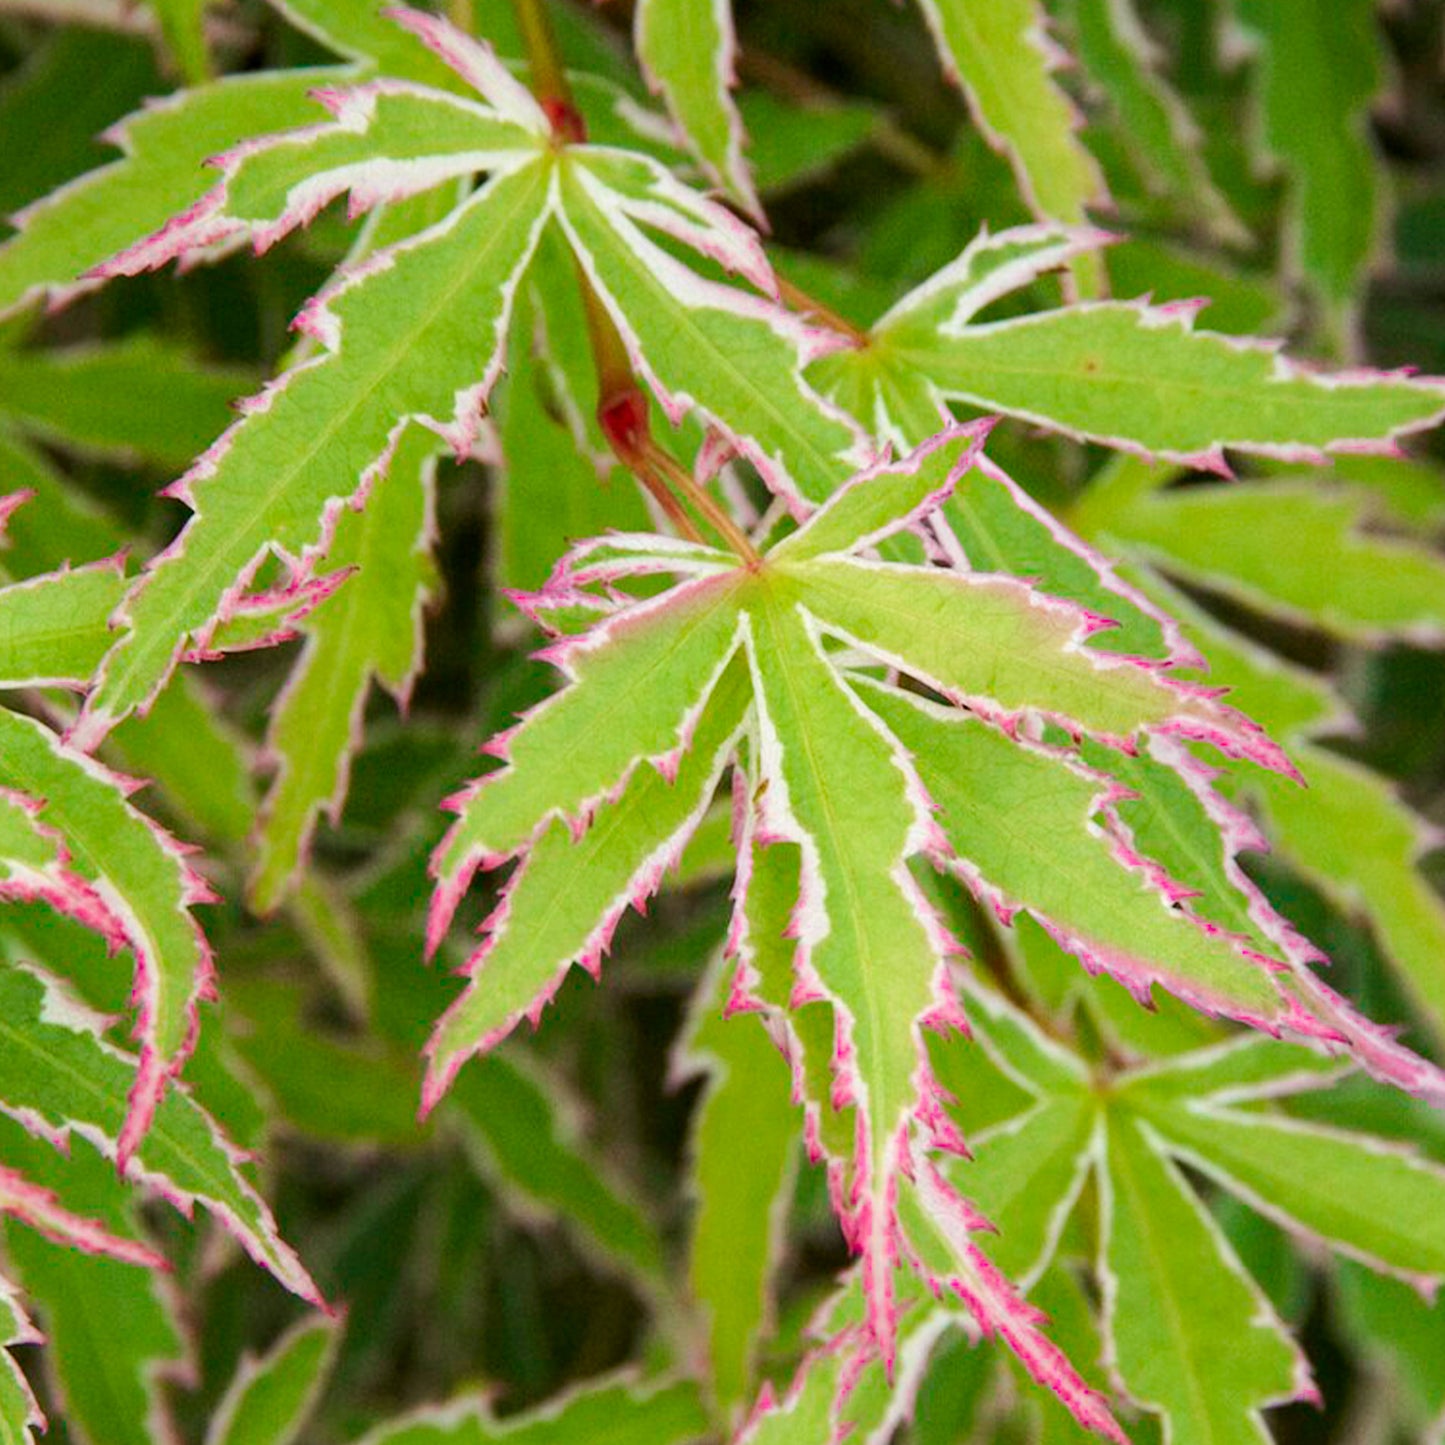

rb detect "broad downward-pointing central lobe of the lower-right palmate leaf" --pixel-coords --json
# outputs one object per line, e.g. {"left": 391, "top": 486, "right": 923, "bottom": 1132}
{"left": 1098, "top": 1116, "right": 1314, "bottom": 1445}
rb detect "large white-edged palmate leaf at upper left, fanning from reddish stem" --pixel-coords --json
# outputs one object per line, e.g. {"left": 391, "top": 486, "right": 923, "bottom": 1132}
{"left": 65, "top": 2, "right": 860, "bottom": 746}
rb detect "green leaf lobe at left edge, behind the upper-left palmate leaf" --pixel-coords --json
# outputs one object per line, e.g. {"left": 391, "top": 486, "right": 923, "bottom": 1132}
{"left": 0, "top": 69, "right": 347, "bottom": 315}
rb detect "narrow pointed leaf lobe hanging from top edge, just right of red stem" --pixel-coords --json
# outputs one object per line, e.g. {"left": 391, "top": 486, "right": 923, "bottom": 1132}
{"left": 633, "top": 0, "right": 762, "bottom": 217}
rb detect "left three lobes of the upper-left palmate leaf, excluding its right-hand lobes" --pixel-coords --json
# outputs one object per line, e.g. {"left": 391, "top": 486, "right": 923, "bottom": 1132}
{"left": 67, "top": 16, "right": 551, "bottom": 746}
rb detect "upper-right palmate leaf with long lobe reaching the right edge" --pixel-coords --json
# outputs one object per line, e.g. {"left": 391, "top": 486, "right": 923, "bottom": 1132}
{"left": 811, "top": 227, "right": 1445, "bottom": 471}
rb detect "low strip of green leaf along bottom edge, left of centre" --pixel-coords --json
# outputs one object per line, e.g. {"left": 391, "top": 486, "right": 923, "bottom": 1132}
{"left": 349, "top": 1380, "right": 708, "bottom": 1445}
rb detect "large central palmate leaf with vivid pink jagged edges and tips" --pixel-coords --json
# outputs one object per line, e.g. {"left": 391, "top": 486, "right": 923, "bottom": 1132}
{"left": 423, "top": 422, "right": 1445, "bottom": 1431}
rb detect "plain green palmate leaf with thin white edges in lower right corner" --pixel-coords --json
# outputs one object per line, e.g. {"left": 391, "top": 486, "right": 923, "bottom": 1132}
{"left": 945, "top": 984, "right": 1445, "bottom": 1445}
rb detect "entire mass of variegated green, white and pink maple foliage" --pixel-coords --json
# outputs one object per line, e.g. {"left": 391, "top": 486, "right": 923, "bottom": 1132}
{"left": 0, "top": 0, "right": 1445, "bottom": 1445}
